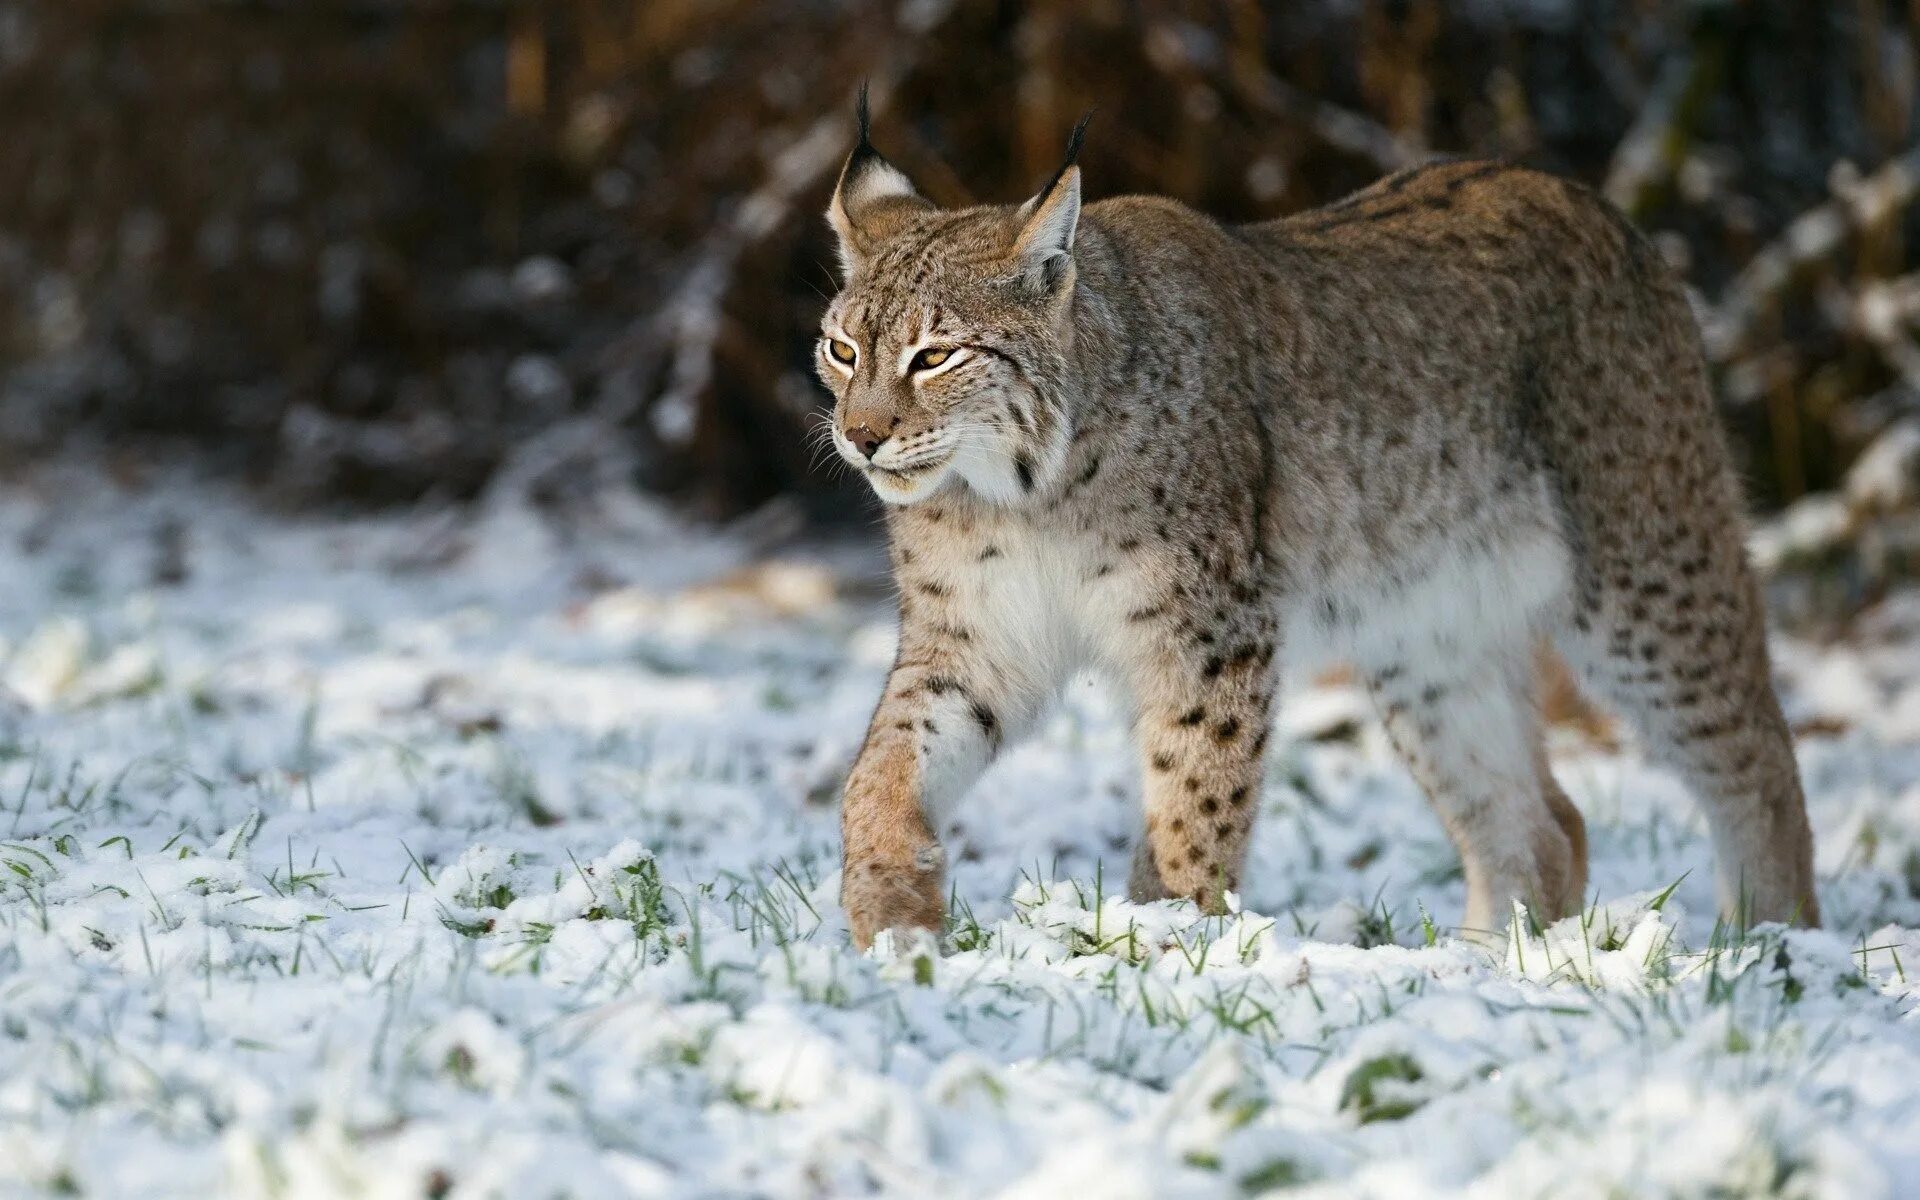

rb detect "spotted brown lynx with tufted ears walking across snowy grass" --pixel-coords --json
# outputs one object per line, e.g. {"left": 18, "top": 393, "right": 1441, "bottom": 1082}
{"left": 818, "top": 96, "right": 1818, "bottom": 948}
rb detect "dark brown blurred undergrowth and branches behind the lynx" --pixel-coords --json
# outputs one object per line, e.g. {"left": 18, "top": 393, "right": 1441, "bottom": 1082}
{"left": 0, "top": 0, "right": 1920, "bottom": 541}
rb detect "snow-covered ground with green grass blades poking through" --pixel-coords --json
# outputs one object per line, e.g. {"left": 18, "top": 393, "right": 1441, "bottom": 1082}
{"left": 0, "top": 472, "right": 1920, "bottom": 1200}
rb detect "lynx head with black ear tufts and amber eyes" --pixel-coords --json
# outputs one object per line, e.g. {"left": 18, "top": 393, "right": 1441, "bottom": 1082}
{"left": 814, "top": 88, "right": 1087, "bottom": 505}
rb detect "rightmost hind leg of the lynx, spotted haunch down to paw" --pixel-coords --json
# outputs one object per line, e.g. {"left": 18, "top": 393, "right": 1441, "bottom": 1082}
{"left": 1534, "top": 247, "right": 1818, "bottom": 925}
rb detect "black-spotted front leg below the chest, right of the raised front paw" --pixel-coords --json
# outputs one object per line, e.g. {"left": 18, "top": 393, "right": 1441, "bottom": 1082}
{"left": 1129, "top": 622, "right": 1273, "bottom": 912}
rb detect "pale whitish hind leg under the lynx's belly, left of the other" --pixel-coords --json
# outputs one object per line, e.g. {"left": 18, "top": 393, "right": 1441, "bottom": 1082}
{"left": 1367, "top": 647, "right": 1586, "bottom": 941}
